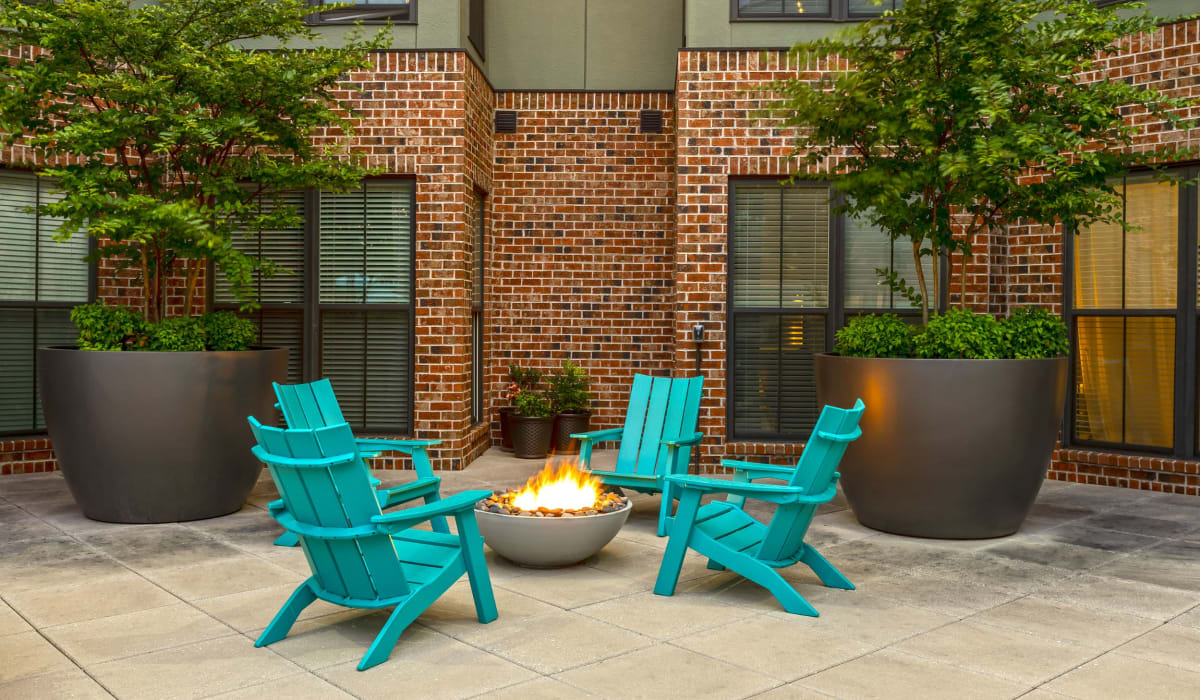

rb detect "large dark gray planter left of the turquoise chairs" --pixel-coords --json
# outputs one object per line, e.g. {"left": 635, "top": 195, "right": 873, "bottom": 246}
{"left": 37, "top": 347, "right": 288, "bottom": 522}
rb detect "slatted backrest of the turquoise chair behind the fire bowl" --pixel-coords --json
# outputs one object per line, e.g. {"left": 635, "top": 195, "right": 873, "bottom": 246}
{"left": 614, "top": 375, "right": 704, "bottom": 475}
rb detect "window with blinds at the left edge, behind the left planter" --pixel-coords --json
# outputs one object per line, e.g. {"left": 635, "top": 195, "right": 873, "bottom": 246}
{"left": 0, "top": 169, "right": 95, "bottom": 435}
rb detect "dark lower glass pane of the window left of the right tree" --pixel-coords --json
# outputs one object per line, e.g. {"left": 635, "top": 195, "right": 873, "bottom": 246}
{"left": 732, "top": 315, "right": 824, "bottom": 437}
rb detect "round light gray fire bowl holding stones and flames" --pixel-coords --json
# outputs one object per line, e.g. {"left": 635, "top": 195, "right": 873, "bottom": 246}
{"left": 475, "top": 501, "right": 634, "bottom": 569}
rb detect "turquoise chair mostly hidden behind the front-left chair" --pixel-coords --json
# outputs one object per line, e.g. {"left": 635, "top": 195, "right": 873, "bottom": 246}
{"left": 271, "top": 379, "right": 450, "bottom": 546}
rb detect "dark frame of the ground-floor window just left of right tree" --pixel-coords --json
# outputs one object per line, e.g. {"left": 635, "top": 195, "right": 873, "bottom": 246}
{"left": 725, "top": 175, "right": 949, "bottom": 443}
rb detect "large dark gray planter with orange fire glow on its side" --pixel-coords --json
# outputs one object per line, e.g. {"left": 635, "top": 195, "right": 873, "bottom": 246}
{"left": 816, "top": 354, "right": 1068, "bottom": 539}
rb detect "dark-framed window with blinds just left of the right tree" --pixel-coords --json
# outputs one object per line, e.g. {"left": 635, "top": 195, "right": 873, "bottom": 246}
{"left": 727, "top": 180, "right": 932, "bottom": 439}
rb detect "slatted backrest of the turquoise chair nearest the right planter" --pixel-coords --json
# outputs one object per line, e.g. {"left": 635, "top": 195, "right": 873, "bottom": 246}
{"left": 758, "top": 399, "right": 865, "bottom": 561}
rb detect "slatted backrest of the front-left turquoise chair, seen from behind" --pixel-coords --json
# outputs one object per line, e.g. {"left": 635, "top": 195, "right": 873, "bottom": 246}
{"left": 250, "top": 418, "right": 408, "bottom": 600}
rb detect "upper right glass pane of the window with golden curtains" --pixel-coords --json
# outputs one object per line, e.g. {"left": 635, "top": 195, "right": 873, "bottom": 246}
{"left": 1124, "top": 175, "right": 1180, "bottom": 309}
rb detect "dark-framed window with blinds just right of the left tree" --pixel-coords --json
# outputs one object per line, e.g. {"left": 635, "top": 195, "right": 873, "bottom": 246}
{"left": 214, "top": 179, "right": 414, "bottom": 432}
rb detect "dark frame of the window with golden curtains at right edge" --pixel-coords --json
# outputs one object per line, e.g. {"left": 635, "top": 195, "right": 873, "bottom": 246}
{"left": 1062, "top": 162, "right": 1200, "bottom": 459}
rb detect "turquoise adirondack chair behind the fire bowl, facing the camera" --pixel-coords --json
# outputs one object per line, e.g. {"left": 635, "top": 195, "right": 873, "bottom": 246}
{"left": 571, "top": 375, "right": 704, "bottom": 537}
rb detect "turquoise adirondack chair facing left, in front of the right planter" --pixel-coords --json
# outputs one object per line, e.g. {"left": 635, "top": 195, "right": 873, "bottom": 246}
{"left": 654, "top": 399, "right": 865, "bottom": 617}
